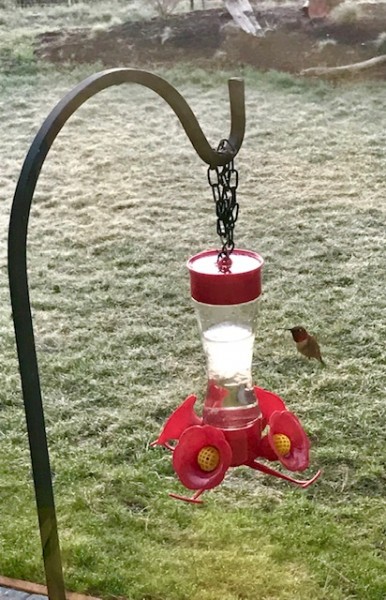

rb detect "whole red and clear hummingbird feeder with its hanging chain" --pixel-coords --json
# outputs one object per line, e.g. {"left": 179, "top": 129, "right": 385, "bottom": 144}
{"left": 152, "top": 150, "right": 321, "bottom": 503}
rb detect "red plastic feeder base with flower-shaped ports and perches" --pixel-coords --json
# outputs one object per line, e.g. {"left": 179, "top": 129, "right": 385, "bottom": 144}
{"left": 152, "top": 387, "right": 321, "bottom": 503}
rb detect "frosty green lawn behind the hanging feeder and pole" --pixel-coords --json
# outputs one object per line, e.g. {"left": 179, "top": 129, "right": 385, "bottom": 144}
{"left": 0, "top": 12, "right": 386, "bottom": 600}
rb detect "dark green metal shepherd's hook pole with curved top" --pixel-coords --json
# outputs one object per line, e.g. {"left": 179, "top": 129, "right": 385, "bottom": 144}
{"left": 8, "top": 69, "right": 245, "bottom": 600}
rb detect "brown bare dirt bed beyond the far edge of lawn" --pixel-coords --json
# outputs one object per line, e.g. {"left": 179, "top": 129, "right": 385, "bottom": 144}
{"left": 36, "top": 3, "right": 386, "bottom": 78}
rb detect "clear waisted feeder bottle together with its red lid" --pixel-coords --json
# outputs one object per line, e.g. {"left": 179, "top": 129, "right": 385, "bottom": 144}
{"left": 188, "top": 250, "right": 263, "bottom": 429}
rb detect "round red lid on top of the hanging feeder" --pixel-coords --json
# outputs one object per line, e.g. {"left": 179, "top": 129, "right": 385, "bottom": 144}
{"left": 187, "top": 250, "right": 264, "bottom": 305}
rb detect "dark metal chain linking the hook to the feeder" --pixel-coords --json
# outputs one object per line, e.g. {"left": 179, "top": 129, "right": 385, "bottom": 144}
{"left": 208, "top": 140, "right": 239, "bottom": 270}
